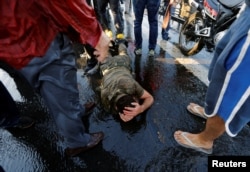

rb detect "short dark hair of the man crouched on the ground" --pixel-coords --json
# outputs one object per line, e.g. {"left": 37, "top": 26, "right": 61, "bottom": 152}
{"left": 116, "top": 95, "right": 136, "bottom": 113}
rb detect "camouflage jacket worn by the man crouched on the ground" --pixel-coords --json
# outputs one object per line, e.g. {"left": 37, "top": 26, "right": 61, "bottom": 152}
{"left": 100, "top": 49, "right": 144, "bottom": 114}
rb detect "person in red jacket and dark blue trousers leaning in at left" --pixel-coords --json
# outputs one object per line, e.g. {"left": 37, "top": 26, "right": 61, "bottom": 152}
{"left": 0, "top": 0, "right": 110, "bottom": 156}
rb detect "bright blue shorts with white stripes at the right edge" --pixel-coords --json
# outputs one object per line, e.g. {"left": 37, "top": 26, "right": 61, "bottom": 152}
{"left": 205, "top": 33, "right": 250, "bottom": 134}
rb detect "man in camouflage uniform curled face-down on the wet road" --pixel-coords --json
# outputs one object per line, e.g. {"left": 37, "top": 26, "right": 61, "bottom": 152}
{"left": 100, "top": 44, "right": 154, "bottom": 122}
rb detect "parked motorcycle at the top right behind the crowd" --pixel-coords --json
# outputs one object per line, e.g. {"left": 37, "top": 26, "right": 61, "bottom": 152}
{"left": 178, "top": 0, "right": 244, "bottom": 56}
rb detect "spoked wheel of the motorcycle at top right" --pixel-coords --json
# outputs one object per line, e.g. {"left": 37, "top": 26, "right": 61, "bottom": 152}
{"left": 179, "top": 12, "right": 204, "bottom": 56}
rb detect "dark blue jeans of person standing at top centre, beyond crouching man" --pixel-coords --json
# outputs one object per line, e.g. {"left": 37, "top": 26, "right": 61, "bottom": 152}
{"left": 133, "top": 0, "right": 160, "bottom": 49}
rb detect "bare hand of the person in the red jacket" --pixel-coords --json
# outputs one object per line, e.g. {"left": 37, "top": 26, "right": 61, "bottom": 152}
{"left": 94, "top": 32, "right": 110, "bottom": 62}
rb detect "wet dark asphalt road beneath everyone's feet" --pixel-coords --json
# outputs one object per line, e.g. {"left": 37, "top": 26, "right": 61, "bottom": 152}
{"left": 0, "top": 12, "right": 250, "bottom": 172}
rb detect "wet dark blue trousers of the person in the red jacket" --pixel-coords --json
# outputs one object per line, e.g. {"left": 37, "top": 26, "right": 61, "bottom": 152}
{"left": 21, "top": 34, "right": 90, "bottom": 147}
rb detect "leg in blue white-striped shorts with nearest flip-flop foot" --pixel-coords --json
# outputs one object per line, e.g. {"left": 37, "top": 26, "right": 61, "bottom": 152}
{"left": 174, "top": 28, "right": 250, "bottom": 154}
